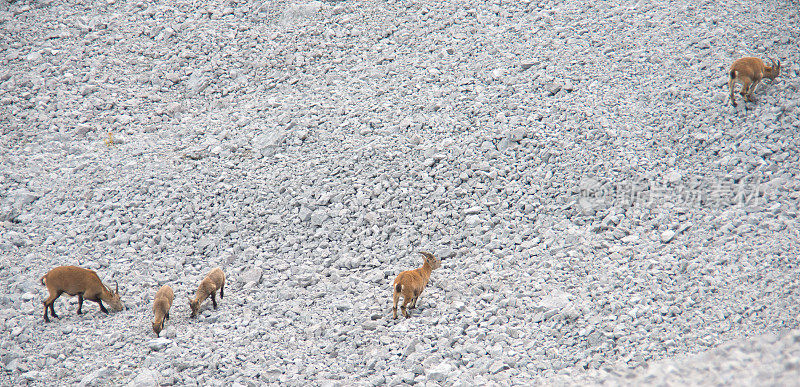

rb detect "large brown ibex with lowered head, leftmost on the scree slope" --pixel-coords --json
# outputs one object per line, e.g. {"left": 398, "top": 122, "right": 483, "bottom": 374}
{"left": 39, "top": 266, "right": 125, "bottom": 322}
